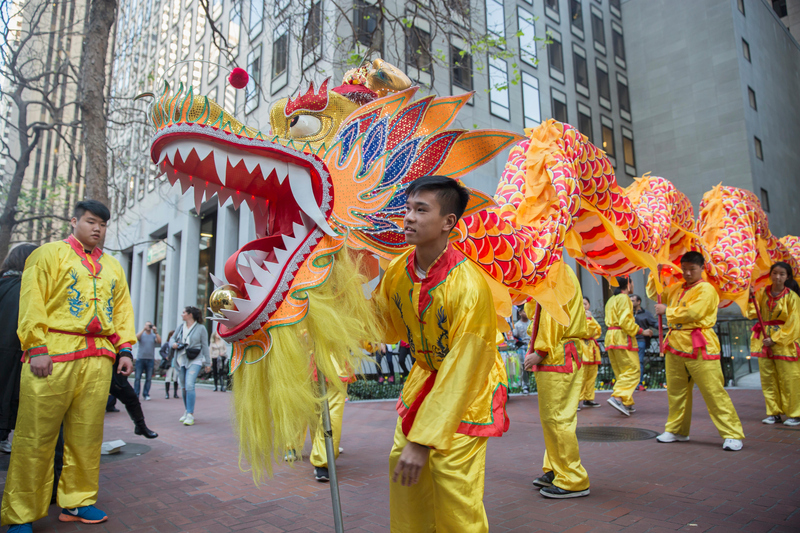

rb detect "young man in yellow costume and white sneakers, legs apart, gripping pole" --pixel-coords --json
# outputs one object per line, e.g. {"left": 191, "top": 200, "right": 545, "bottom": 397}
{"left": 647, "top": 252, "right": 744, "bottom": 451}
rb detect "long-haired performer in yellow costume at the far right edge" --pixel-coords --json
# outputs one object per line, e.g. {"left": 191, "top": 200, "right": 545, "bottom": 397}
{"left": 748, "top": 262, "right": 800, "bottom": 426}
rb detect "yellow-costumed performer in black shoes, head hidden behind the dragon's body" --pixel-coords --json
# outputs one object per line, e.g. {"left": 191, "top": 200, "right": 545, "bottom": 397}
{"left": 525, "top": 264, "right": 589, "bottom": 498}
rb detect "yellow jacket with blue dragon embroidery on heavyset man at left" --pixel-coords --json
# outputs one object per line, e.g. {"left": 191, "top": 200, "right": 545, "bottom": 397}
{"left": 17, "top": 235, "right": 136, "bottom": 362}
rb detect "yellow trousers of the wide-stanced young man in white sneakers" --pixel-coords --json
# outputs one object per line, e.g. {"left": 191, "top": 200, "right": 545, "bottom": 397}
{"left": 665, "top": 352, "right": 744, "bottom": 439}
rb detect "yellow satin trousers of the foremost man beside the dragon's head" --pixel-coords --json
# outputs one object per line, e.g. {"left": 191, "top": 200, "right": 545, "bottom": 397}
{"left": 389, "top": 418, "right": 489, "bottom": 533}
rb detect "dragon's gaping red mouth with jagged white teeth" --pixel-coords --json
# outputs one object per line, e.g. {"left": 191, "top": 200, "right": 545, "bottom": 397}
{"left": 151, "top": 124, "right": 336, "bottom": 341}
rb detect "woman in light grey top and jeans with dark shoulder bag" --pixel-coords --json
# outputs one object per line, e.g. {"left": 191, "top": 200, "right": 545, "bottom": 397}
{"left": 172, "top": 306, "right": 211, "bottom": 426}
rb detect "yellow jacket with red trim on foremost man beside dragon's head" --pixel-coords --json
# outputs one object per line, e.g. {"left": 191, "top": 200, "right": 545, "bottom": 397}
{"left": 374, "top": 245, "right": 509, "bottom": 452}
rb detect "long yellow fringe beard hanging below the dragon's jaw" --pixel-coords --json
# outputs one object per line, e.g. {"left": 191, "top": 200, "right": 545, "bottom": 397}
{"left": 233, "top": 248, "right": 382, "bottom": 483}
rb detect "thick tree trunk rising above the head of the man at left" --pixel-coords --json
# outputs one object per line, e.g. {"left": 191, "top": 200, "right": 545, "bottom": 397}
{"left": 78, "top": 0, "right": 117, "bottom": 205}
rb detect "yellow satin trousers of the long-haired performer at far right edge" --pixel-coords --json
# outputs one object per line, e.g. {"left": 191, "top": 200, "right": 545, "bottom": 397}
{"left": 758, "top": 357, "right": 800, "bottom": 418}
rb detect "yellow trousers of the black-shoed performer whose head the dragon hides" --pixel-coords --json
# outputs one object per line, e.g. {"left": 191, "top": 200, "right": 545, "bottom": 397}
{"left": 536, "top": 366, "right": 597, "bottom": 491}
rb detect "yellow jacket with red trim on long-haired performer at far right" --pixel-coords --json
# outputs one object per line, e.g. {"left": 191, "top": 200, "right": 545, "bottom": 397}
{"left": 747, "top": 285, "right": 800, "bottom": 361}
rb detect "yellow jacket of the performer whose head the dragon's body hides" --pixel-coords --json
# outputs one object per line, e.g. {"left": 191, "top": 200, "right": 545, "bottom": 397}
{"left": 525, "top": 264, "right": 589, "bottom": 373}
